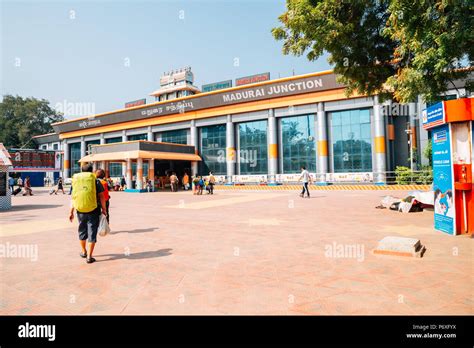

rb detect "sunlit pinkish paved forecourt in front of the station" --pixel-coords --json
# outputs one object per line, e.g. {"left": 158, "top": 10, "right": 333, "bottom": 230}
{"left": 0, "top": 190, "right": 474, "bottom": 314}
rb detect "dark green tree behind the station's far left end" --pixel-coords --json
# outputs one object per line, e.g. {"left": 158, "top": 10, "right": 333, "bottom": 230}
{"left": 0, "top": 95, "right": 64, "bottom": 147}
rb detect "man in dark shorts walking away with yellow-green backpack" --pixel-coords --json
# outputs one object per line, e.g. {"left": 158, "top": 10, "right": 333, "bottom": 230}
{"left": 69, "top": 164, "right": 107, "bottom": 263}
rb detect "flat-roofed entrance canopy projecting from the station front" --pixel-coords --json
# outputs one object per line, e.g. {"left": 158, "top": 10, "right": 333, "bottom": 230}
{"left": 79, "top": 140, "right": 201, "bottom": 163}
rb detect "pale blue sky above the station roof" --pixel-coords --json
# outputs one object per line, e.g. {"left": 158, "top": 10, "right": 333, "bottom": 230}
{"left": 1, "top": 0, "right": 330, "bottom": 118}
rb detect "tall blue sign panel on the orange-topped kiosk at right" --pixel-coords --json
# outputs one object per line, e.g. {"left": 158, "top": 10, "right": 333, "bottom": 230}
{"left": 431, "top": 124, "right": 455, "bottom": 234}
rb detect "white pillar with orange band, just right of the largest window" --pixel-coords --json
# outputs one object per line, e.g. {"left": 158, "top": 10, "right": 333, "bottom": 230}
{"left": 372, "top": 96, "right": 387, "bottom": 184}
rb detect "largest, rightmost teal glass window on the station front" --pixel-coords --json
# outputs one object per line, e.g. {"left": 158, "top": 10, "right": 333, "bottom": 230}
{"left": 330, "top": 109, "right": 372, "bottom": 173}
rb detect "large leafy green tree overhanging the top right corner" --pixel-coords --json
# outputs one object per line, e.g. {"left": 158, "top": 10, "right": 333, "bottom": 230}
{"left": 272, "top": 0, "right": 474, "bottom": 103}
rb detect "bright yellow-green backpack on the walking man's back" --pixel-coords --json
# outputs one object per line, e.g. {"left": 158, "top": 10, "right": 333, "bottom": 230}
{"left": 72, "top": 172, "right": 97, "bottom": 213}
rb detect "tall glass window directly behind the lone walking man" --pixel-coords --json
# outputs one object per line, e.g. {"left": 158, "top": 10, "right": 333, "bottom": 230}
{"left": 280, "top": 115, "right": 316, "bottom": 174}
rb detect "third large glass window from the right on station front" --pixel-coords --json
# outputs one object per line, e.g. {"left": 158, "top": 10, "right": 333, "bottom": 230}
{"left": 239, "top": 121, "right": 268, "bottom": 175}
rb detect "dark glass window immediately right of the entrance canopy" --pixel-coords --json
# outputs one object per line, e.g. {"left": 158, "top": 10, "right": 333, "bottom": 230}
{"left": 199, "top": 124, "right": 227, "bottom": 175}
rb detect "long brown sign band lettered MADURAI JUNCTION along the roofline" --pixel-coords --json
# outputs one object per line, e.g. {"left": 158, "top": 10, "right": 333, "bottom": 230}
{"left": 53, "top": 74, "right": 344, "bottom": 133}
